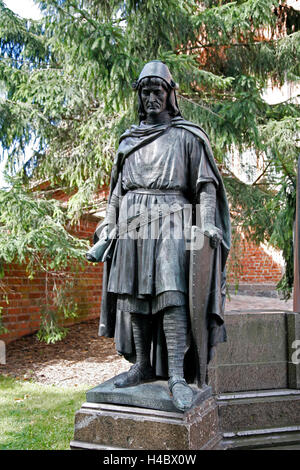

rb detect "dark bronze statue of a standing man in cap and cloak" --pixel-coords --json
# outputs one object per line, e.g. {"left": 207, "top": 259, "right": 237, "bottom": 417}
{"left": 89, "top": 61, "right": 230, "bottom": 411}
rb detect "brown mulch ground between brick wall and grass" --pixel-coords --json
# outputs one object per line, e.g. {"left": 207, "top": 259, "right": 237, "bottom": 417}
{"left": 0, "top": 319, "right": 127, "bottom": 386}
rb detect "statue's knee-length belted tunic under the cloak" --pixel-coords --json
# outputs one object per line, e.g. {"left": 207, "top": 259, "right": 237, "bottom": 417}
{"left": 108, "top": 124, "right": 219, "bottom": 313}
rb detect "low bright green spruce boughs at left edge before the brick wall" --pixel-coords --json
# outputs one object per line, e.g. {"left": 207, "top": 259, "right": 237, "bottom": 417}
{"left": 0, "top": 178, "right": 88, "bottom": 277}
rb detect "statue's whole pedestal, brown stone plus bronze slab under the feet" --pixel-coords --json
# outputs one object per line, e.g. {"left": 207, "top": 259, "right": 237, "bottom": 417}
{"left": 70, "top": 380, "right": 221, "bottom": 450}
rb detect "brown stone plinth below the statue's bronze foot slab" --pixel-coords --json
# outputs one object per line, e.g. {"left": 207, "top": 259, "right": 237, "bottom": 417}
{"left": 70, "top": 397, "right": 221, "bottom": 450}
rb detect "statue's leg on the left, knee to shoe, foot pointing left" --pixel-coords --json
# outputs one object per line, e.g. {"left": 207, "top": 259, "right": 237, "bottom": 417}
{"left": 114, "top": 314, "right": 154, "bottom": 388}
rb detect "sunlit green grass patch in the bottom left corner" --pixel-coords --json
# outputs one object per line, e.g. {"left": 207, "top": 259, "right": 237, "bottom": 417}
{"left": 0, "top": 376, "right": 89, "bottom": 450}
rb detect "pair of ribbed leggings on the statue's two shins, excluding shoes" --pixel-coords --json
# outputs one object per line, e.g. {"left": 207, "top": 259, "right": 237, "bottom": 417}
{"left": 131, "top": 306, "right": 187, "bottom": 377}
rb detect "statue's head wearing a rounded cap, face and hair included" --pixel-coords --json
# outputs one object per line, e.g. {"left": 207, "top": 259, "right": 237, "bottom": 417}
{"left": 133, "top": 60, "right": 181, "bottom": 121}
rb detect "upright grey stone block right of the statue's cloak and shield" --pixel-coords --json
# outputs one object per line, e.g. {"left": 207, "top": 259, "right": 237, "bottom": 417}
{"left": 208, "top": 312, "right": 289, "bottom": 394}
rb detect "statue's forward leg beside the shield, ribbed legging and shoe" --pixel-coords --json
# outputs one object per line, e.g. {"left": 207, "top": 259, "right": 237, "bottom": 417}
{"left": 163, "top": 307, "right": 193, "bottom": 411}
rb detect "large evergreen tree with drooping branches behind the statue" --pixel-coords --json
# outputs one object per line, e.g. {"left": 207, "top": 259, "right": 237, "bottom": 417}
{"left": 0, "top": 0, "right": 300, "bottom": 338}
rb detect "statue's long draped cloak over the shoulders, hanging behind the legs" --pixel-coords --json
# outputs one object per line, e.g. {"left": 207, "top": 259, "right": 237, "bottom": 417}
{"left": 94, "top": 117, "right": 230, "bottom": 381}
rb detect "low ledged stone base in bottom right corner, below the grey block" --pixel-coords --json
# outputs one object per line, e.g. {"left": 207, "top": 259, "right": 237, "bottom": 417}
{"left": 217, "top": 389, "right": 300, "bottom": 449}
